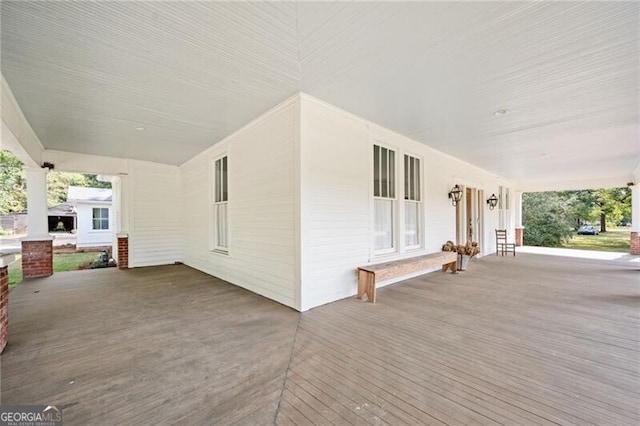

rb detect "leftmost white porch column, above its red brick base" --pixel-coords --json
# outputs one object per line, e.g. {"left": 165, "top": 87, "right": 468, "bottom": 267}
{"left": 26, "top": 167, "right": 51, "bottom": 240}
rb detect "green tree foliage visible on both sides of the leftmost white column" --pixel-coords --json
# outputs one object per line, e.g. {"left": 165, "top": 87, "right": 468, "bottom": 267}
{"left": 0, "top": 150, "right": 111, "bottom": 215}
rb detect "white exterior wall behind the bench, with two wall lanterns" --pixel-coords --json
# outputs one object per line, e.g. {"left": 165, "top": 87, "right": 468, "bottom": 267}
{"left": 300, "top": 95, "right": 515, "bottom": 311}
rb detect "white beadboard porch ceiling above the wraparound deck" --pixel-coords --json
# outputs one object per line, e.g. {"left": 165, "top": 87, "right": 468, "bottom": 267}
{"left": 1, "top": 0, "right": 640, "bottom": 184}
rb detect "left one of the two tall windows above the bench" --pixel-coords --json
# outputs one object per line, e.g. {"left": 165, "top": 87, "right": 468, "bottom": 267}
{"left": 373, "top": 145, "right": 396, "bottom": 253}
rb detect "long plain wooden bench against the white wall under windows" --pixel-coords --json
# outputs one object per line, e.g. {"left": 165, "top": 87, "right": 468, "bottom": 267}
{"left": 358, "top": 251, "right": 458, "bottom": 303}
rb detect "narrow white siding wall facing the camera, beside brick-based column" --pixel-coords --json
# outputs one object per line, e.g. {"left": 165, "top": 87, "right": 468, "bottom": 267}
{"left": 127, "top": 161, "right": 183, "bottom": 267}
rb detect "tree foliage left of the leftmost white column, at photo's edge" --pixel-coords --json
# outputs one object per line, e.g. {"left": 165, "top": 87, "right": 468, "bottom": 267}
{"left": 0, "top": 150, "right": 27, "bottom": 215}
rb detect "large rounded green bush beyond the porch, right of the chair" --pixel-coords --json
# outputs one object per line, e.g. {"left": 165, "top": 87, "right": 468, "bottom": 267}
{"left": 522, "top": 192, "right": 572, "bottom": 247}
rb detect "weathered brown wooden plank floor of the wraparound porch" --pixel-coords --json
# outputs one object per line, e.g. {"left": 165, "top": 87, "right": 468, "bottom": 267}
{"left": 1, "top": 254, "right": 640, "bottom": 425}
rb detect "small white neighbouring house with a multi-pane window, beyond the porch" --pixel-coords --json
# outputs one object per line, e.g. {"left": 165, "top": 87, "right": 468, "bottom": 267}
{"left": 67, "top": 186, "right": 114, "bottom": 247}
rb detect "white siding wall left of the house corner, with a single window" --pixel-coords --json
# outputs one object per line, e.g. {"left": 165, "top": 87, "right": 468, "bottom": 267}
{"left": 180, "top": 96, "right": 300, "bottom": 309}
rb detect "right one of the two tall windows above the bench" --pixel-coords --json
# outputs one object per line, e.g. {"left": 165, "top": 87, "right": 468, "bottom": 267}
{"left": 404, "top": 155, "right": 422, "bottom": 248}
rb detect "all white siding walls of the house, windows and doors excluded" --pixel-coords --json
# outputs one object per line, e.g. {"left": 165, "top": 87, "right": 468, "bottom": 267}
{"left": 51, "top": 95, "right": 515, "bottom": 311}
